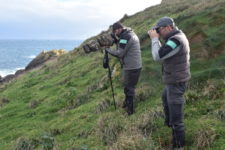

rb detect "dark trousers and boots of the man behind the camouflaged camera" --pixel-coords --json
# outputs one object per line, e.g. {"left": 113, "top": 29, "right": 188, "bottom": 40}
{"left": 123, "top": 68, "right": 141, "bottom": 115}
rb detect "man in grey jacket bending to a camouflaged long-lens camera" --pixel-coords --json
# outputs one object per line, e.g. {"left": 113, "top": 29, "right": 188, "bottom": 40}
{"left": 106, "top": 22, "right": 142, "bottom": 115}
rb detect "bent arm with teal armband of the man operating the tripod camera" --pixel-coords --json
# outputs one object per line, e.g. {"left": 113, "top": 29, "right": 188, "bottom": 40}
{"left": 107, "top": 35, "right": 132, "bottom": 58}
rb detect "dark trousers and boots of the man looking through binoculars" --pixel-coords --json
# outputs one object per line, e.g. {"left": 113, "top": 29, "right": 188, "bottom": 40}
{"left": 162, "top": 82, "right": 187, "bottom": 148}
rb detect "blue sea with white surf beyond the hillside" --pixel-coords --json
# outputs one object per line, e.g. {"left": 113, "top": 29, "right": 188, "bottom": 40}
{"left": 0, "top": 40, "right": 82, "bottom": 77}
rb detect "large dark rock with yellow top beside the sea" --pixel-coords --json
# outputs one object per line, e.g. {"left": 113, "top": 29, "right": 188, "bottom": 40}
{"left": 25, "top": 50, "right": 66, "bottom": 70}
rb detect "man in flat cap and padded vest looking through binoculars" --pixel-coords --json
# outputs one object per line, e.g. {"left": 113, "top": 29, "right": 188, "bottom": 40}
{"left": 148, "top": 17, "right": 191, "bottom": 148}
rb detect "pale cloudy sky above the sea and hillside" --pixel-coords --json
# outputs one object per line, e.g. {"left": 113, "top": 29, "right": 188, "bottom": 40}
{"left": 0, "top": 0, "right": 161, "bottom": 40}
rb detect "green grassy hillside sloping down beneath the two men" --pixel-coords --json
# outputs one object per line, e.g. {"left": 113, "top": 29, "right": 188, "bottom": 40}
{"left": 0, "top": 0, "right": 225, "bottom": 150}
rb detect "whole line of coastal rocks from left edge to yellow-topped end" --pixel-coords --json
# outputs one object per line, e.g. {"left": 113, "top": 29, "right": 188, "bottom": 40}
{"left": 0, "top": 49, "right": 66, "bottom": 84}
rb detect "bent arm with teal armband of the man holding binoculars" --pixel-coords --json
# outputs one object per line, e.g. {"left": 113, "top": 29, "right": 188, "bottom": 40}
{"left": 152, "top": 38, "right": 181, "bottom": 61}
